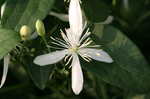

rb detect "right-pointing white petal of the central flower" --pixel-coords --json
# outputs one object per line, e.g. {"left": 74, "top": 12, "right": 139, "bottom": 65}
{"left": 79, "top": 48, "right": 113, "bottom": 63}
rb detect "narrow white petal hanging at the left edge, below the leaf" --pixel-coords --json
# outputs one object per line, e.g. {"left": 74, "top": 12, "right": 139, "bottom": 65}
{"left": 0, "top": 54, "right": 10, "bottom": 88}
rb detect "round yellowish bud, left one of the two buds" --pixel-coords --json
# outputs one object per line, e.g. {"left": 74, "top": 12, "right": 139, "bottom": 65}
{"left": 20, "top": 25, "right": 31, "bottom": 41}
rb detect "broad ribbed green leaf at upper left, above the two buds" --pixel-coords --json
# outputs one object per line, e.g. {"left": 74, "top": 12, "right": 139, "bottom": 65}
{"left": 2, "top": 0, "right": 54, "bottom": 31}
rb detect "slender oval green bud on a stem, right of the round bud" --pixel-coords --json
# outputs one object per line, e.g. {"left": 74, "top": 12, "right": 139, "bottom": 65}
{"left": 35, "top": 19, "right": 45, "bottom": 36}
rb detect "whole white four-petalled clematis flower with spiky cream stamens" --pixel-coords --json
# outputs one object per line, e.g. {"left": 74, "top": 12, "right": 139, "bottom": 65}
{"left": 34, "top": 0, "right": 113, "bottom": 95}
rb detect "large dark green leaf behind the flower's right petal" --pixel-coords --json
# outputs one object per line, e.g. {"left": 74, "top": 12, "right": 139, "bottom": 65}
{"left": 84, "top": 24, "right": 150, "bottom": 93}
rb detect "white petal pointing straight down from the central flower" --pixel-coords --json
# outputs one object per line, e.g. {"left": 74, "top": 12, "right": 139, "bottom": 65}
{"left": 71, "top": 54, "right": 83, "bottom": 95}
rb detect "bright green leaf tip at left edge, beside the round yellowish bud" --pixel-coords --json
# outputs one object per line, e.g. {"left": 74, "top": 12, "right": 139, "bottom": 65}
{"left": 0, "top": 28, "right": 20, "bottom": 59}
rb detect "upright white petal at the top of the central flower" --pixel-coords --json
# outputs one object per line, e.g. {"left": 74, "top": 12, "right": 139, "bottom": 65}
{"left": 69, "top": 0, "right": 83, "bottom": 37}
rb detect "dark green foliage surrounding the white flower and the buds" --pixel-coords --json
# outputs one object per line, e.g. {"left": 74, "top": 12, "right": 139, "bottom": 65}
{"left": 0, "top": 0, "right": 150, "bottom": 99}
